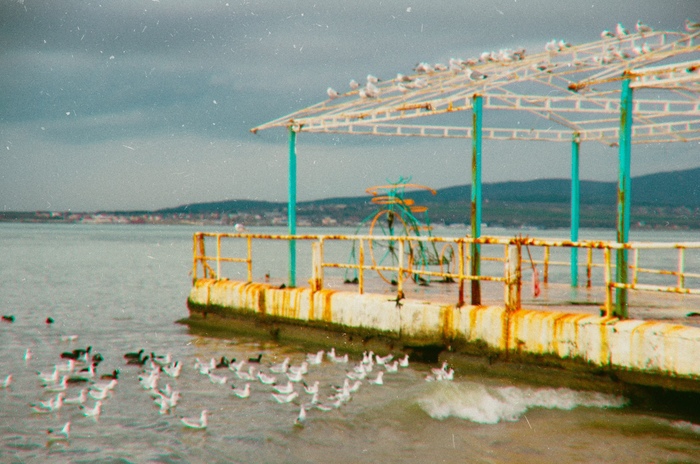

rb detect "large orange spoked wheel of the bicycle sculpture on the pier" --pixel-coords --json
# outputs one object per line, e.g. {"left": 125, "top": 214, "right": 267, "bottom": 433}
{"left": 368, "top": 209, "right": 413, "bottom": 285}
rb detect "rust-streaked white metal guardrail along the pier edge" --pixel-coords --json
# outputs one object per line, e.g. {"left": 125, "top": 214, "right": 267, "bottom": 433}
{"left": 192, "top": 232, "right": 700, "bottom": 314}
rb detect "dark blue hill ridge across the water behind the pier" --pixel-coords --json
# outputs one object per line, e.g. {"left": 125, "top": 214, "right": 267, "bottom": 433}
{"left": 157, "top": 168, "right": 700, "bottom": 213}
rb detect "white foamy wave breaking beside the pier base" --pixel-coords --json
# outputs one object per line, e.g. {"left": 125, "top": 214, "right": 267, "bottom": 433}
{"left": 417, "top": 382, "right": 627, "bottom": 424}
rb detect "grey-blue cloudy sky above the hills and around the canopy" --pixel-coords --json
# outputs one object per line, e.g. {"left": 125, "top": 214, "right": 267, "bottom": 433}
{"left": 0, "top": 0, "right": 700, "bottom": 212}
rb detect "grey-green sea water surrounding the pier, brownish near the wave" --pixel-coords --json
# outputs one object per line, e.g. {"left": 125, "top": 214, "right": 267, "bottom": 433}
{"left": 0, "top": 223, "right": 700, "bottom": 463}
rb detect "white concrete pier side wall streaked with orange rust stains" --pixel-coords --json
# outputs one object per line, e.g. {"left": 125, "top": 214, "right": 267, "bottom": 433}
{"left": 189, "top": 279, "right": 700, "bottom": 379}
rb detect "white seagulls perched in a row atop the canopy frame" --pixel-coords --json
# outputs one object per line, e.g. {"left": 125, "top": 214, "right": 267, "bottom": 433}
{"left": 326, "top": 19, "right": 700, "bottom": 100}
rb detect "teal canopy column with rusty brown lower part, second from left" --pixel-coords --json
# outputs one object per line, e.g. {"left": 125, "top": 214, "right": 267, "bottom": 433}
{"left": 471, "top": 95, "right": 483, "bottom": 305}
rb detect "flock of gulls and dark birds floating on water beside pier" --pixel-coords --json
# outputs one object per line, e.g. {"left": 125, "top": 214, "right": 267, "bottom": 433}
{"left": 0, "top": 320, "right": 454, "bottom": 446}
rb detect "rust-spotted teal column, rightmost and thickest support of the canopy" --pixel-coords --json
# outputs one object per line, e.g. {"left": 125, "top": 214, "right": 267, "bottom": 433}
{"left": 613, "top": 79, "right": 632, "bottom": 319}
